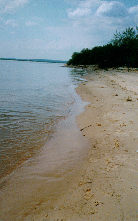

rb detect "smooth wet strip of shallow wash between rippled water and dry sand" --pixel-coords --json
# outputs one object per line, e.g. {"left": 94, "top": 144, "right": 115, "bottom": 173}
{"left": 0, "top": 80, "right": 89, "bottom": 220}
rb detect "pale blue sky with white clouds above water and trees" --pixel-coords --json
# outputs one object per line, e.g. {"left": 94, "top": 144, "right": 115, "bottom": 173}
{"left": 0, "top": 0, "right": 138, "bottom": 60}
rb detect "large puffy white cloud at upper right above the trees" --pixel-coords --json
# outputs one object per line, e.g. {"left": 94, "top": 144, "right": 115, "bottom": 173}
{"left": 68, "top": 0, "right": 138, "bottom": 28}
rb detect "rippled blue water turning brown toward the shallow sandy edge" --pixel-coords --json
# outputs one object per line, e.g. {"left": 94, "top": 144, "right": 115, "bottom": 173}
{"left": 0, "top": 61, "right": 84, "bottom": 180}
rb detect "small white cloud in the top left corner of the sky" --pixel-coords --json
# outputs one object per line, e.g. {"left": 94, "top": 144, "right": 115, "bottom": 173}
{"left": 0, "top": 0, "right": 28, "bottom": 12}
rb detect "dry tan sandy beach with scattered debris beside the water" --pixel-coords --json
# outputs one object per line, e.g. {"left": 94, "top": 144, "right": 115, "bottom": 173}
{"left": 36, "top": 69, "right": 138, "bottom": 221}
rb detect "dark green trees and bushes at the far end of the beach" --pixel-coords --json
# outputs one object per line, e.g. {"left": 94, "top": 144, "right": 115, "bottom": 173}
{"left": 67, "top": 27, "right": 138, "bottom": 68}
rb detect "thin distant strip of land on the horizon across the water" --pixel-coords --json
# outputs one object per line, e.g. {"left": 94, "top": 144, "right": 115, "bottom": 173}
{"left": 0, "top": 58, "right": 67, "bottom": 63}
